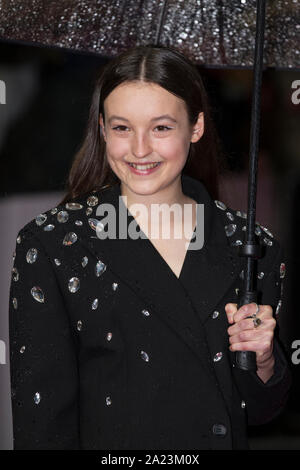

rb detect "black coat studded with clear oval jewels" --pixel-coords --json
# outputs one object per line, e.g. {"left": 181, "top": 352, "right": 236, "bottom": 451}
{"left": 10, "top": 176, "right": 291, "bottom": 450}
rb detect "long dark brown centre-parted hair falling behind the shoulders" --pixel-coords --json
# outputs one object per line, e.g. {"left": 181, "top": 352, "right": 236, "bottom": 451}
{"left": 61, "top": 45, "right": 225, "bottom": 204}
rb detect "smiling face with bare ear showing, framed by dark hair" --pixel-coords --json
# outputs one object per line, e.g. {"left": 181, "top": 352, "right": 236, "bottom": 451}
{"left": 99, "top": 81, "right": 204, "bottom": 202}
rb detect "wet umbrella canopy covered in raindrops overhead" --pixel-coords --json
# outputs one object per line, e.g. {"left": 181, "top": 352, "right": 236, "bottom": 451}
{"left": 0, "top": 0, "right": 300, "bottom": 69}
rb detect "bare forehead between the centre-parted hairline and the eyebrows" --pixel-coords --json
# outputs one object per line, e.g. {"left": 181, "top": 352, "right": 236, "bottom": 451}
{"left": 104, "top": 82, "right": 185, "bottom": 119}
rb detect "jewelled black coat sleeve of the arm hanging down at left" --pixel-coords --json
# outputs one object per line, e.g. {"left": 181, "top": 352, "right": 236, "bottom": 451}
{"left": 9, "top": 227, "right": 79, "bottom": 449}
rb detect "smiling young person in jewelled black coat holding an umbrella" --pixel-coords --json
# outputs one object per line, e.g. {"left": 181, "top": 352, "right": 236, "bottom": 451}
{"left": 10, "top": 46, "right": 291, "bottom": 450}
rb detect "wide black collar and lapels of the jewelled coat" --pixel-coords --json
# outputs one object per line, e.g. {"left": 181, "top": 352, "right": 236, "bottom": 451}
{"left": 79, "top": 175, "right": 245, "bottom": 376}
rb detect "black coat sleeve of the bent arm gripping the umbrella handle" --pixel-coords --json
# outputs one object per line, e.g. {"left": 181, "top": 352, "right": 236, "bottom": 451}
{"left": 232, "top": 242, "right": 292, "bottom": 425}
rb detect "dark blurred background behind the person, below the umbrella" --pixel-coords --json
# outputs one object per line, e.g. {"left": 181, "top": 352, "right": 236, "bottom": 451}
{"left": 0, "top": 35, "right": 300, "bottom": 449}
